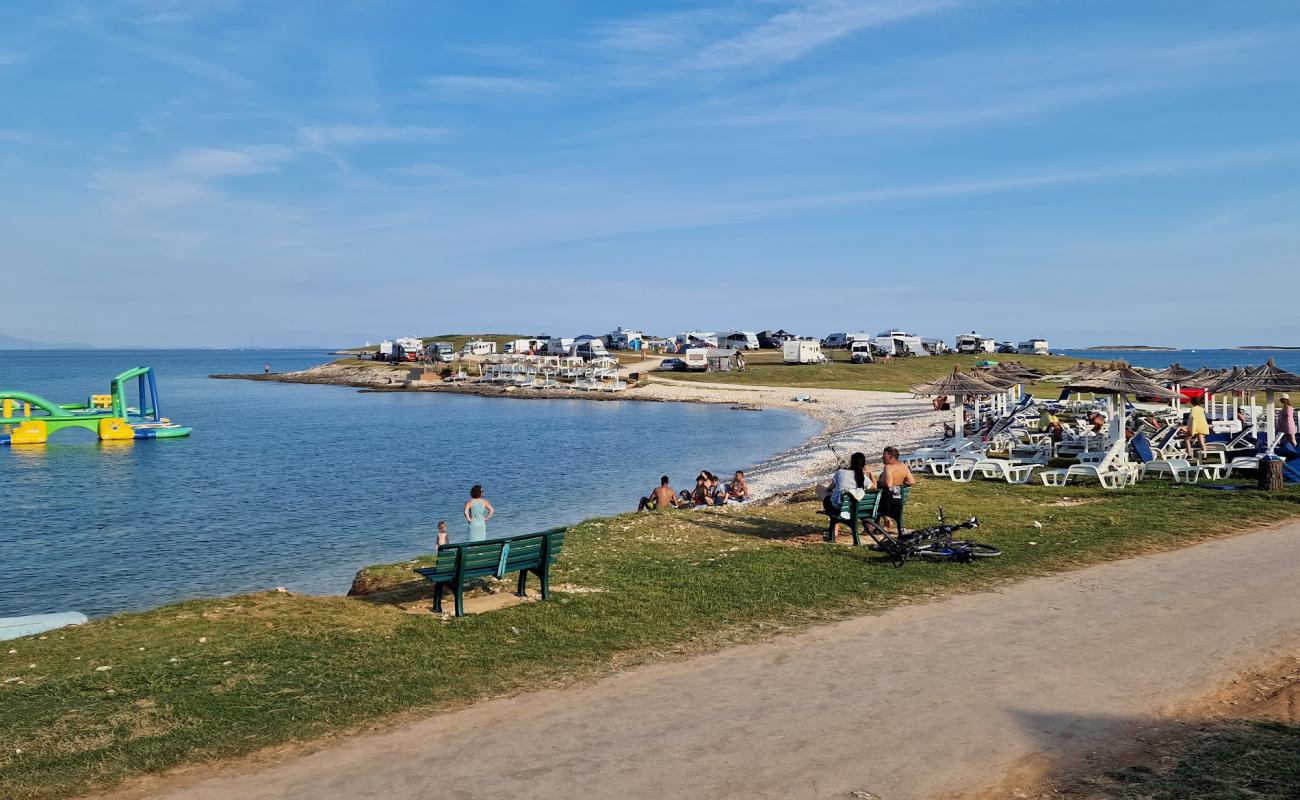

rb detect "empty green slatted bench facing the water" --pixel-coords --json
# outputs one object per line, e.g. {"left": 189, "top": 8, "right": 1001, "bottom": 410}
{"left": 415, "top": 528, "right": 566, "bottom": 617}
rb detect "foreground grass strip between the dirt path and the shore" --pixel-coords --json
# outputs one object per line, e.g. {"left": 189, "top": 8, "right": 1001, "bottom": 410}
{"left": 0, "top": 480, "right": 1300, "bottom": 800}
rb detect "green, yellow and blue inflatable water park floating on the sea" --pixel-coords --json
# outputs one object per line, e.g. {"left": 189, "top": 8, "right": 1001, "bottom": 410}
{"left": 0, "top": 367, "right": 190, "bottom": 445}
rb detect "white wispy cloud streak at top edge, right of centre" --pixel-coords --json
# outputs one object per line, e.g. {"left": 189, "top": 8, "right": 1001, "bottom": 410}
{"left": 683, "top": 0, "right": 958, "bottom": 69}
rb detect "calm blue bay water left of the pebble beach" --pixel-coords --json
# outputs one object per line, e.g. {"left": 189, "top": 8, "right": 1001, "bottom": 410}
{"left": 0, "top": 350, "right": 816, "bottom": 617}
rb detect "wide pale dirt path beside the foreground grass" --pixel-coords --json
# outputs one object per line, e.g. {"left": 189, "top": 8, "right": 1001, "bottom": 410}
{"left": 101, "top": 524, "right": 1300, "bottom": 800}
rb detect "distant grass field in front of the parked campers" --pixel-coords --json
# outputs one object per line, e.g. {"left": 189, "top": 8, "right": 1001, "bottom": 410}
{"left": 655, "top": 350, "right": 1081, "bottom": 398}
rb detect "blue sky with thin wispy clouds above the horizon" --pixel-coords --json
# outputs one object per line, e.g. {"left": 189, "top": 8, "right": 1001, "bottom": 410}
{"left": 0, "top": 0, "right": 1300, "bottom": 347}
